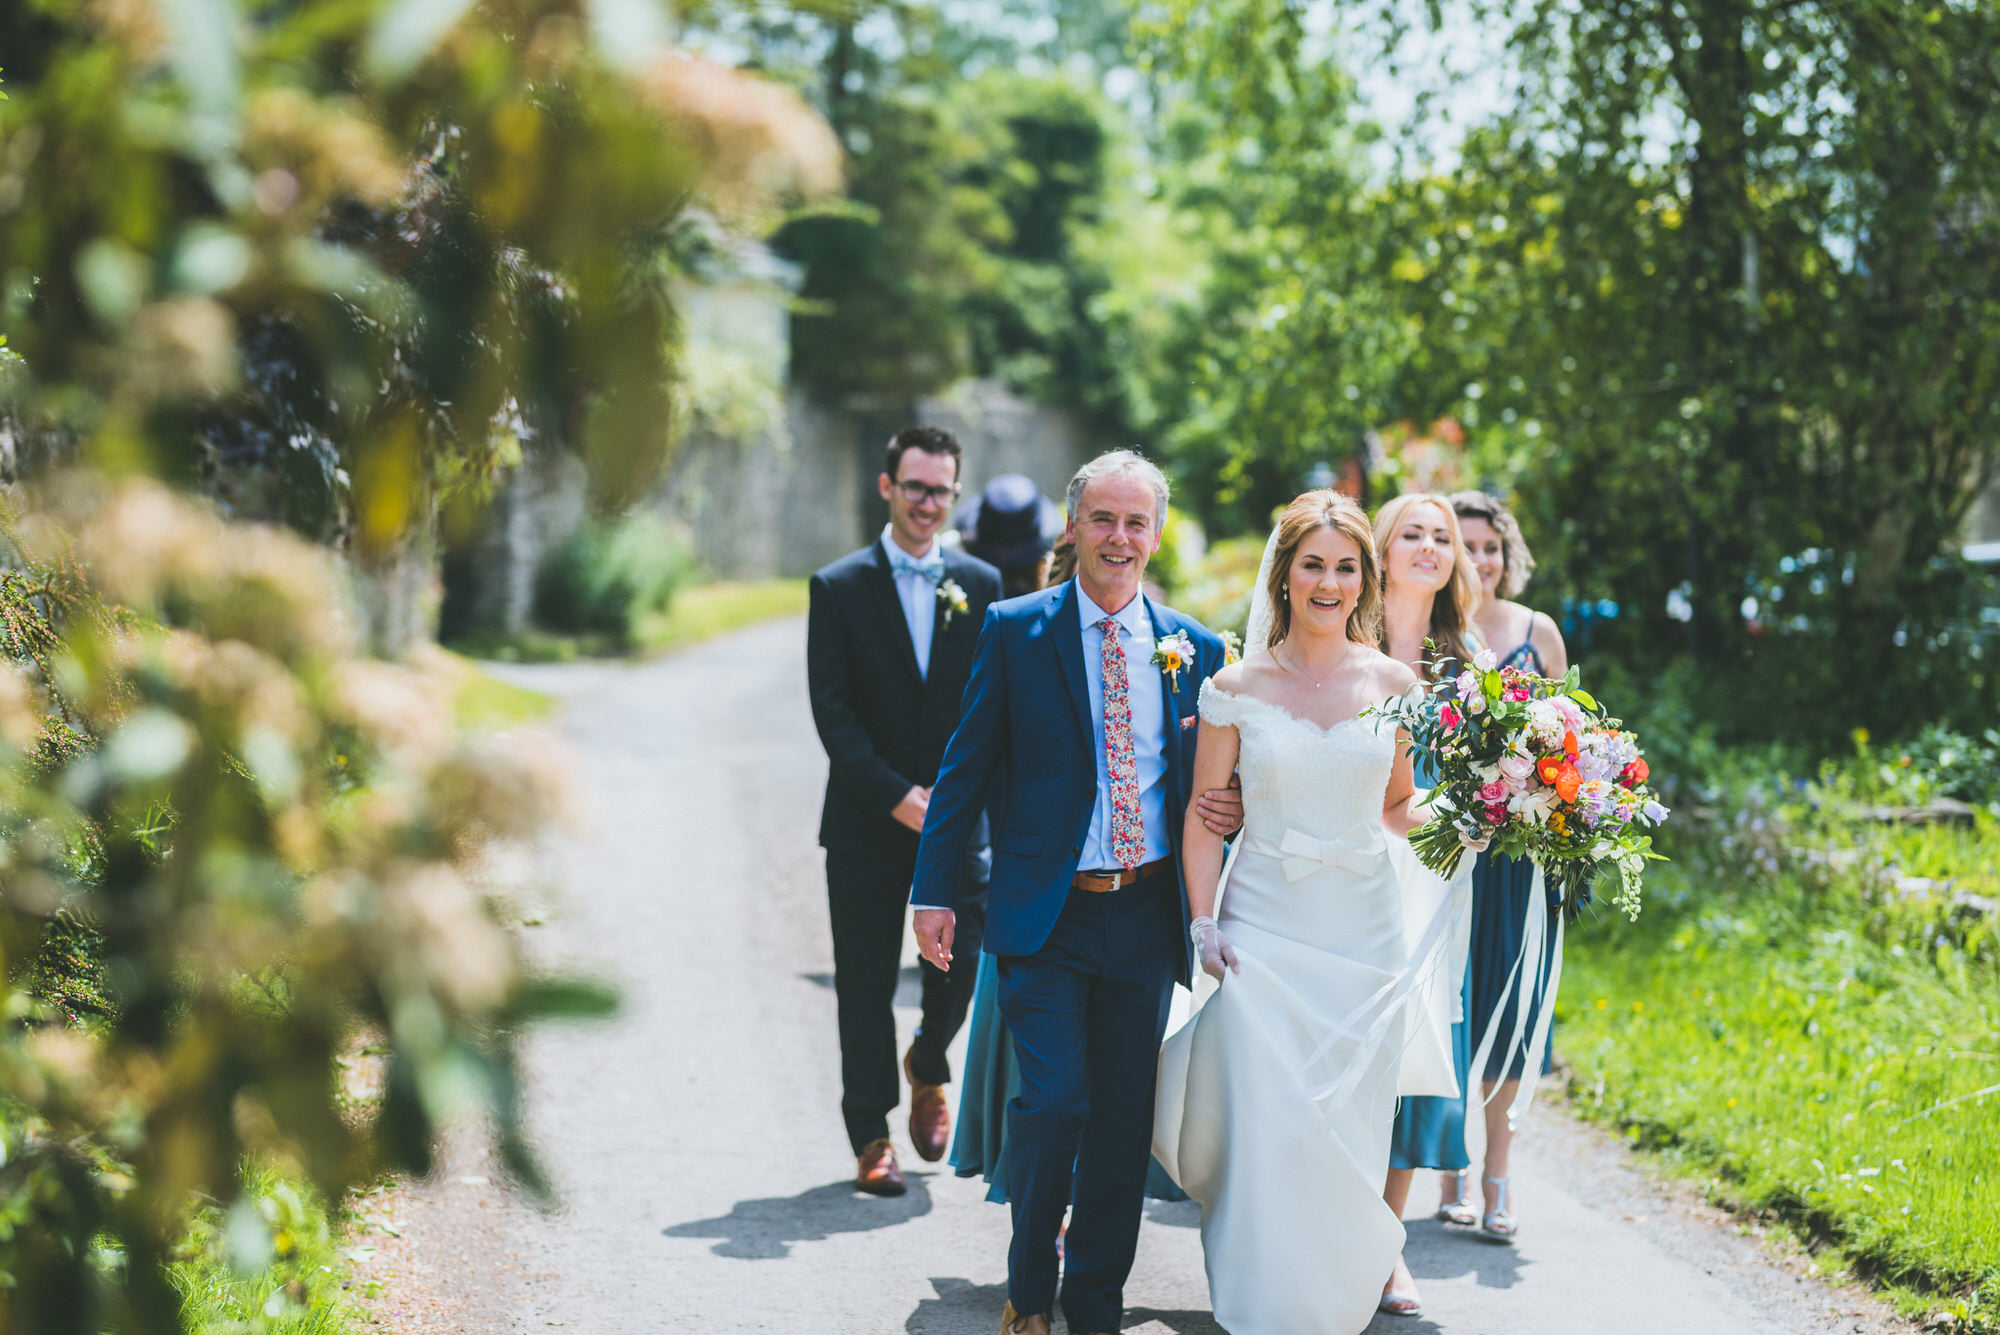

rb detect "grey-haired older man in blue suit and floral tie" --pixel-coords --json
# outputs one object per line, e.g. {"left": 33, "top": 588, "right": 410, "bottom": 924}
{"left": 910, "top": 450, "right": 1224, "bottom": 1335}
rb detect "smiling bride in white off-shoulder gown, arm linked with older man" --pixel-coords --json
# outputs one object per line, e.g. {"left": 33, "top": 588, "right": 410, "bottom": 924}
{"left": 1154, "top": 492, "right": 1466, "bottom": 1335}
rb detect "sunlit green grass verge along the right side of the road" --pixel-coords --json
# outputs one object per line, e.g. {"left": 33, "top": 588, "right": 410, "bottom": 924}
{"left": 1558, "top": 855, "right": 2000, "bottom": 1331}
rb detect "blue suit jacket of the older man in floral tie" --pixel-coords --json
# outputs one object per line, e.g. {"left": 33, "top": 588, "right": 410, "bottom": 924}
{"left": 910, "top": 582, "right": 1222, "bottom": 983}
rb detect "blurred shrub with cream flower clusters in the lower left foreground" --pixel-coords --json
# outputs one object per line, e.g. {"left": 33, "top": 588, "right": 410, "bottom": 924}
{"left": 0, "top": 480, "right": 608, "bottom": 1335}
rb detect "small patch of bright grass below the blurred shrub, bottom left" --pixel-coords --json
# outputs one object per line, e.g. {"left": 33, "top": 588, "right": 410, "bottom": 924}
{"left": 172, "top": 1171, "right": 368, "bottom": 1335}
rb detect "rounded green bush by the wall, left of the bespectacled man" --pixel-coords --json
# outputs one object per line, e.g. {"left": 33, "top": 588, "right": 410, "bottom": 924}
{"left": 534, "top": 512, "right": 694, "bottom": 648}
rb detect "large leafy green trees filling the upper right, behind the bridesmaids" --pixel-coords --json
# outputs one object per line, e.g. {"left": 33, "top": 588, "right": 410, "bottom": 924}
{"left": 1144, "top": 0, "right": 2000, "bottom": 735}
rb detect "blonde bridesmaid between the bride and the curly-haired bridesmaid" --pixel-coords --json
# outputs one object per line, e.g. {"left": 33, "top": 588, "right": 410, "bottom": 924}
{"left": 1374, "top": 492, "right": 1480, "bottom": 1317}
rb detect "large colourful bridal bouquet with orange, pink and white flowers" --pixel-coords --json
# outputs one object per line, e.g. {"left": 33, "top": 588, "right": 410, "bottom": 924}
{"left": 1370, "top": 654, "right": 1668, "bottom": 917}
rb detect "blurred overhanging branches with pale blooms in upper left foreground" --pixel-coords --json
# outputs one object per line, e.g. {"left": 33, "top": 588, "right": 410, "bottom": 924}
{"left": 0, "top": 0, "right": 838, "bottom": 646}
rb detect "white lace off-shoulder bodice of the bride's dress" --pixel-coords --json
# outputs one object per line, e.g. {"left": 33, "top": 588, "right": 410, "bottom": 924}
{"left": 1200, "top": 681, "right": 1396, "bottom": 839}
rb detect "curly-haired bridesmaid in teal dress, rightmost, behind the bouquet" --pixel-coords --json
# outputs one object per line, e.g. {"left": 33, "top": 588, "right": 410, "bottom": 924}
{"left": 1452, "top": 492, "right": 1570, "bottom": 1243}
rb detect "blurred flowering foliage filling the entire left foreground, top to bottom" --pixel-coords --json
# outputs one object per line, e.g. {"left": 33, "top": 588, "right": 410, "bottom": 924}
{"left": 0, "top": 0, "right": 838, "bottom": 1335}
